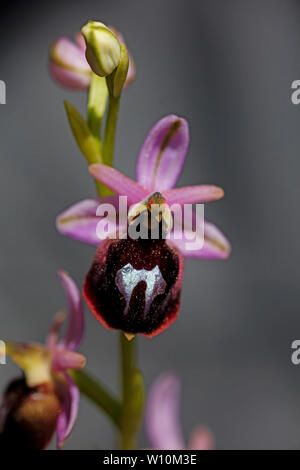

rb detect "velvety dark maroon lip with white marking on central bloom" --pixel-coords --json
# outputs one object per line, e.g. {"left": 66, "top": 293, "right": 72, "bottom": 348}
{"left": 83, "top": 233, "right": 184, "bottom": 337}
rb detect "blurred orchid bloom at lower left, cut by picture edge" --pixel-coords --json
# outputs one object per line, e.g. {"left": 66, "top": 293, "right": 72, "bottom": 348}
{"left": 0, "top": 271, "right": 85, "bottom": 449}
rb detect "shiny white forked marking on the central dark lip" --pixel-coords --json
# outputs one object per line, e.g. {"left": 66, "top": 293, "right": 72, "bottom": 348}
{"left": 115, "top": 263, "right": 167, "bottom": 315}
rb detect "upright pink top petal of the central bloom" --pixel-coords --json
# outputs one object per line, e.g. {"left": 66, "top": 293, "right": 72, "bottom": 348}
{"left": 137, "top": 114, "right": 189, "bottom": 192}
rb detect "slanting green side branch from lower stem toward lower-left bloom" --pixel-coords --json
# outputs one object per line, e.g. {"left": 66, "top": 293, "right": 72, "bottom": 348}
{"left": 70, "top": 370, "right": 121, "bottom": 429}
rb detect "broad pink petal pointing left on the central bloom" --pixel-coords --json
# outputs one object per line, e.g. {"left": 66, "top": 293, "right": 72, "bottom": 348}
{"left": 56, "top": 196, "right": 119, "bottom": 246}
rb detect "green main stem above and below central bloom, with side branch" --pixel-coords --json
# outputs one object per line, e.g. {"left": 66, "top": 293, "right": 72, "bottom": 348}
{"left": 84, "top": 83, "right": 144, "bottom": 450}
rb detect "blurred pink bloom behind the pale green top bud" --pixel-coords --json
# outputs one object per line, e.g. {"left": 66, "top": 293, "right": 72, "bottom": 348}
{"left": 49, "top": 26, "right": 135, "bottom": 90}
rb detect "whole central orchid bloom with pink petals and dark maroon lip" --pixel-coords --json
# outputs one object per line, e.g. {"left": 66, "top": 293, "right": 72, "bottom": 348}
{"left": 57, "top": 115, "right": 230, "bottom": 337}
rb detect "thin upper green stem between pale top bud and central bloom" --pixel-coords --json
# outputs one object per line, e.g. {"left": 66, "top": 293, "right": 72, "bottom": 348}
{"left": 103, "top": 94, "right": 120, "bottom": 166}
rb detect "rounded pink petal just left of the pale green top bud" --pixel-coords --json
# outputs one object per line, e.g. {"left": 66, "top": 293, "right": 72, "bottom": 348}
{"left": 49, "top": 37, "right": 91, "bottom": 89}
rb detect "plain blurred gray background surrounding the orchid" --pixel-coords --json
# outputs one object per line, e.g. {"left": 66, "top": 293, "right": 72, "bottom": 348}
{"left": 0, "top": 0, "right": 300, "bottom": 449}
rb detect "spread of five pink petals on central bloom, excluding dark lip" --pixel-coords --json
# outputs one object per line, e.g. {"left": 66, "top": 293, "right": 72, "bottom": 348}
{"left": 56, "top": 115, "right": 230, "bottom": 259}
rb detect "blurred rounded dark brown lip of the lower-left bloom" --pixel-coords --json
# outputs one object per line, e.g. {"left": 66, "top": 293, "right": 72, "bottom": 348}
{"left": 0, "top": 378, "right": 61, "bottom": 450}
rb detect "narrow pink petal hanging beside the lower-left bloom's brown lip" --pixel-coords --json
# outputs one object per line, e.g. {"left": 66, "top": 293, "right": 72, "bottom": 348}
{"left": 56, "top": 373, "right": 80, "bottom": 449}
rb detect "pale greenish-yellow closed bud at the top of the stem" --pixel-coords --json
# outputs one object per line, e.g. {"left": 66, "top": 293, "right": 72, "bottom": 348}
{"left": 81, "top": 21, "right": 121, "bottom": 77}
